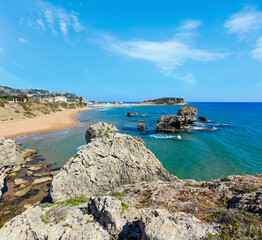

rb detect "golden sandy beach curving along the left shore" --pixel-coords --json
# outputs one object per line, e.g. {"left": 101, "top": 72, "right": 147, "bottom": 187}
{"left": 0, "top": 108, "right": 92, "bottom": 138}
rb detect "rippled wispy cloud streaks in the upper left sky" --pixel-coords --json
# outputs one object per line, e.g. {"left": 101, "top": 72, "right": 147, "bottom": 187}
{"left": 22, "top": 0, "right": 84, "bottom": 38}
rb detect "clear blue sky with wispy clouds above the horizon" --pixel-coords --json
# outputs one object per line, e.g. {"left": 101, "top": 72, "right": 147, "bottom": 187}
{"left": 0, "top": 0, "right": 262, "bottom": 102}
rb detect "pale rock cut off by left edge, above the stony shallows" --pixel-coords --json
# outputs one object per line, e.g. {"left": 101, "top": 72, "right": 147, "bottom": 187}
{"left": 0, "top": 137, "right": 24, "bottom": 197}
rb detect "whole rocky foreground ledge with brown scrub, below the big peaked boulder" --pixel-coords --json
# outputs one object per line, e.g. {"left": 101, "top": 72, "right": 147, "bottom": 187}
{"left": 4, "top": 174, "right": 262, "bottom": 240}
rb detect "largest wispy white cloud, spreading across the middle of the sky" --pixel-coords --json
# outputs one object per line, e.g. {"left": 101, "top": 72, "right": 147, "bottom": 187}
{"left": 98, "top": 34, "right": 228, "bottom": 84}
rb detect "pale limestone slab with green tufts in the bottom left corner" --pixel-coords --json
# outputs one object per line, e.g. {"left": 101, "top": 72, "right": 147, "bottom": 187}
{"left": 0, "top": 206, "right": 109, "bottom": 240}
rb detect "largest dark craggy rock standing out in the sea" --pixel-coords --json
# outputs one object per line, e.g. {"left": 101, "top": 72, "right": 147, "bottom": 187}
{"left": 156, "top": 106, "right": 197, "bottom": 132}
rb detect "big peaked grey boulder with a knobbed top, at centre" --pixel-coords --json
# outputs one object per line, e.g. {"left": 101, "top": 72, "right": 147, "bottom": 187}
{"left": 50, "top": 122, "right": 176, "bottom": 201}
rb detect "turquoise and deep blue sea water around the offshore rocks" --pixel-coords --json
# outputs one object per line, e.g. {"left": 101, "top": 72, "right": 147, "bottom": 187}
{"left": 18, "top": 103, "right": 262, "bottom": 180}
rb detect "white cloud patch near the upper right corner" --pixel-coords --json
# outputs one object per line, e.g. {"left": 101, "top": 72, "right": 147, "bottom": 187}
{"left": 224, "top": 6, "right": 262, "bottom": 38}
